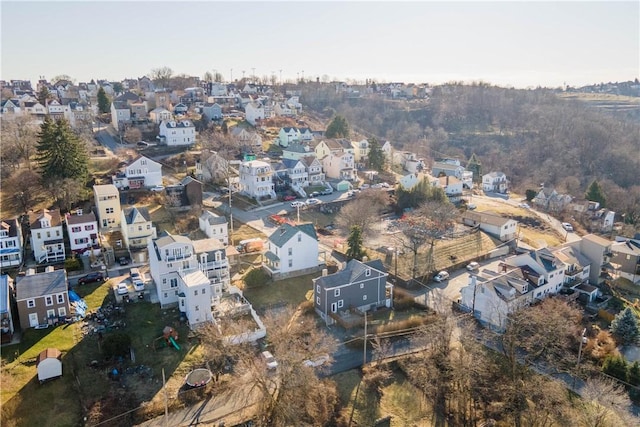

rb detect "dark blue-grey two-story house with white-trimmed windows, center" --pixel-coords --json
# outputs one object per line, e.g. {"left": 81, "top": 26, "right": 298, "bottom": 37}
{"left": 313, "top": 259, "right": 393, "bottom": 325}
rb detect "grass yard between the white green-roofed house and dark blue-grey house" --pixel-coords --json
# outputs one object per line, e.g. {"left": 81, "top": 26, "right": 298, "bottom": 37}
{"left": 243, "top": 272, "right": 322, "bottom": 310}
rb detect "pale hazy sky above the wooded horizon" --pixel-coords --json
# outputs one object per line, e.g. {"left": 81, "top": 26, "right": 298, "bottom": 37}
{"left": 0, "top": 0, "right": 640, "bottom": 88}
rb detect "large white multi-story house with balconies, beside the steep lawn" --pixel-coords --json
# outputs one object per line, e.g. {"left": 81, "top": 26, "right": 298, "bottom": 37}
{"left": 148, "top": 232, "right": 229, "bottom": 327}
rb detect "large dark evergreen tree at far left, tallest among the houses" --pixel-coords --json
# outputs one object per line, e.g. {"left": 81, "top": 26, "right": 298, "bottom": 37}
{"left": 36, "top": 117, "right": 89, "bottom": 183}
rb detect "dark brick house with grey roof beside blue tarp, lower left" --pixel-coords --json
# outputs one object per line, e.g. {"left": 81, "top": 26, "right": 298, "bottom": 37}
{"left": 16, "top": 267, "right": 70, "bottom": 328}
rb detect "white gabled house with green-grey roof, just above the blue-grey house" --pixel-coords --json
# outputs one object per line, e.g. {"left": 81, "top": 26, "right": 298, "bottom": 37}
{"left": 263, "top": 223, "right": 318, "bottom": 278}
